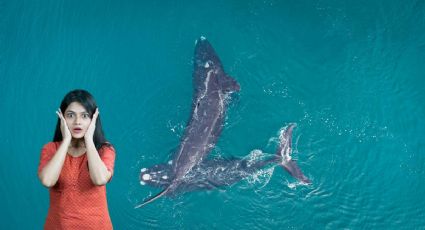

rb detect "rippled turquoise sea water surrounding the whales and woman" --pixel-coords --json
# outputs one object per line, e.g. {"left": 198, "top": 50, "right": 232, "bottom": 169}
{"left": 0, "top": 0, "right": 425, "bottom": 229}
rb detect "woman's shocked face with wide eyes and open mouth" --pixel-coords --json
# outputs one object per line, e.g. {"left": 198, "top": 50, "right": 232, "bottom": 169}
{"left": 64, "top": 102, "right": 91, "bottom": 139}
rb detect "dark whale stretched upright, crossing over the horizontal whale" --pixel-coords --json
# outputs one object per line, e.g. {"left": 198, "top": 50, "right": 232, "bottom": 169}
{"left": 135, "top": 37, "right": 240, "bottom": 208}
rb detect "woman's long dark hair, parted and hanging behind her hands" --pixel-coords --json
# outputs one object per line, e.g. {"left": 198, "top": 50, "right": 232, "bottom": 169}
{"left": 53, "top": 89, "right": 111, "bottom": 150}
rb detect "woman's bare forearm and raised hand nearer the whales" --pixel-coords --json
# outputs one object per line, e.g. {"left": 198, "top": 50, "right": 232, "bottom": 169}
{"left": 84, "top": 109, "right": 112, "bottom": 186}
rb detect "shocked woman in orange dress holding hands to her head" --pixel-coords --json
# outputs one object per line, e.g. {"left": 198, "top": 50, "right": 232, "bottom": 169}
{"left": 38, "top": 90, "right": 115, "bottom": 229}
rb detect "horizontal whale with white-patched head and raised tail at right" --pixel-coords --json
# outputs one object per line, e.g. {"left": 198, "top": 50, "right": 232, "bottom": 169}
{"left": 139, "top": 123, "right": 311, "bottom": 196}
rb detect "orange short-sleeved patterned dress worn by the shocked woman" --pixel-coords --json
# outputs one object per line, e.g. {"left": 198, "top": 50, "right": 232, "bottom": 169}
{"left": 38, "top": 142, "right": 115, "bottom": 230}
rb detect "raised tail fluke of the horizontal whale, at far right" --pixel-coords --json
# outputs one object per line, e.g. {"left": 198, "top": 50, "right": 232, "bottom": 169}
{"left": 276, "top": 123, "right": 311, "bottom": 184}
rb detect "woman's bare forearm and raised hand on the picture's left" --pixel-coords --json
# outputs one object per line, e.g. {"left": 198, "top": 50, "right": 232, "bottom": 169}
{"left": 38, "top": 110, "right": 72, "bottom": 188}
